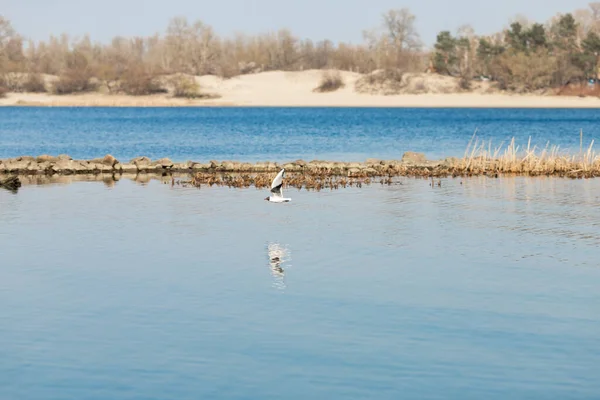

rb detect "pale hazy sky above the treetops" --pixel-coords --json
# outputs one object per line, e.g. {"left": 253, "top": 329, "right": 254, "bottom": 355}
{"left": 0, "top": 0, "right": 589, "bottom": 46}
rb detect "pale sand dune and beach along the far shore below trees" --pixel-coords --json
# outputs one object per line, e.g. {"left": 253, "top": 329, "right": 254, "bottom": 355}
{"left": 0, "top": 70, "right": 600, "bottom": 108}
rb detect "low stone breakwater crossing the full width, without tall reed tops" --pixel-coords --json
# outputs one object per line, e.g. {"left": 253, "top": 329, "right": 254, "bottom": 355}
{"left": 0, "top": 152, "right": 600, "bottom": 179}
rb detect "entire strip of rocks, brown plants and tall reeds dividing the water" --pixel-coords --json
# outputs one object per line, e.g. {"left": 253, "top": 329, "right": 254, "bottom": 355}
{"left": 0, "top": 136, "right": 600, "bottom": 188}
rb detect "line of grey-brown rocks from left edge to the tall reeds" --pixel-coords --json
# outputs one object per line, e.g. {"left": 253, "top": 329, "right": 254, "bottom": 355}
{"left": 0, "top": 152, "right": 456, "bottom": 176}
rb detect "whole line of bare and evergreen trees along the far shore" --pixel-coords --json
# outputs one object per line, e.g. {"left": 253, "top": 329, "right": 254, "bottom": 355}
{"left": 0, "top": 3, "right": 600, "bottom": 95}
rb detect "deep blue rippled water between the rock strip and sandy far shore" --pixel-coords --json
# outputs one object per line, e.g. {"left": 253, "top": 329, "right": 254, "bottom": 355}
{"left": 0, "top": 107, "right": 600, "bottom": 162}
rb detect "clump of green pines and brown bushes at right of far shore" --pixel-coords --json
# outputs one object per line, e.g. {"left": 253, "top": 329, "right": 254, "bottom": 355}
{"left": 432, "top": 2, "right": 600, "bottom": 92}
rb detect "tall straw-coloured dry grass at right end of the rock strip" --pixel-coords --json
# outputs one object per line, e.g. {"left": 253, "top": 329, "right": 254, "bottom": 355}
{"left": 456, "top": 132, "right": 600, "bottom": 178}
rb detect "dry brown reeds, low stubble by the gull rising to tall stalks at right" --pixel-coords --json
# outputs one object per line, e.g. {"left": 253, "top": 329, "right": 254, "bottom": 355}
{"left": 182, "top": 131, "right": 600, "bottom": 191}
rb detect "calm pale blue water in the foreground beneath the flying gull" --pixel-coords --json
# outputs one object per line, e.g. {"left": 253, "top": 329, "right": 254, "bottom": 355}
{"left": 0, "top": 178, "right": 600, "bottom": 400}
